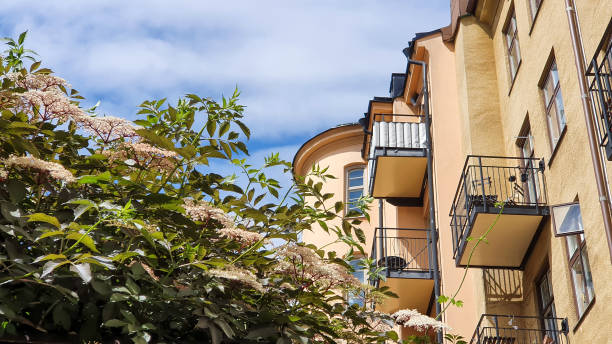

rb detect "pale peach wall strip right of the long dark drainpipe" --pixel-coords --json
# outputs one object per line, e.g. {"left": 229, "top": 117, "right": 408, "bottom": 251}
{"left": 413, "top": 34, "right": 494, "bottom": 338}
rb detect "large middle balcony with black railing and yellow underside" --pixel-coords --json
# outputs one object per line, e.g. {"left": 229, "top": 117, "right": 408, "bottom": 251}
{"left": 450, "top": 155, "right": 549, "bottom": 268}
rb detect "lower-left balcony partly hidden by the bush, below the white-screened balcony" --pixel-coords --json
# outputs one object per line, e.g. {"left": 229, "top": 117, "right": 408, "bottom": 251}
{"left": 371, "top": 228, "right": 434, "bottom": 314}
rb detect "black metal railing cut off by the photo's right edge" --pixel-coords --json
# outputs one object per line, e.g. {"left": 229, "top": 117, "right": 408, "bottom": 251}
{"left": 586, "top": 35, "right": 612, "bottom": 160}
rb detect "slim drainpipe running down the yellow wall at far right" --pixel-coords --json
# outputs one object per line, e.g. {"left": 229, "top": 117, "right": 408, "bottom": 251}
{"left": 565, "top": 0, "right": 612, "bottom": 262}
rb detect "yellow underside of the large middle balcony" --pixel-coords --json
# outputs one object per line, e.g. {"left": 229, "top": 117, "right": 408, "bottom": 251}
{"left": 456, "top": 206, "right": 547, "bottom": 268}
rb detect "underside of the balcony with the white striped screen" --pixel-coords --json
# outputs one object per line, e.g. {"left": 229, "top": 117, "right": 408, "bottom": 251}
{"left": 370, "top": 148, "right": 427, "bottom": 199}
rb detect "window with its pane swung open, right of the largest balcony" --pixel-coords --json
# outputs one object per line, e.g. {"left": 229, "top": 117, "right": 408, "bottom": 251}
{"left": 553, "top": 203, "right": 595, "bottom": 317}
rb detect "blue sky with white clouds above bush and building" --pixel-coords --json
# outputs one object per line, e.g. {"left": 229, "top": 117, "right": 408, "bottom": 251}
{"left": 0, "top": 0, "right": 450, "bottom": 188}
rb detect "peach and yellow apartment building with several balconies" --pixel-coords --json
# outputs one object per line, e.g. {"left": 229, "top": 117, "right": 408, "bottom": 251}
{"left": 294, "top": 0, "right": 612, "bottom": 344}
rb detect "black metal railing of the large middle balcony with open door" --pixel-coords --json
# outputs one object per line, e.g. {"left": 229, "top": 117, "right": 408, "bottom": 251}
{"left": 449, "top": 155, "right": 548, "bottom": 255}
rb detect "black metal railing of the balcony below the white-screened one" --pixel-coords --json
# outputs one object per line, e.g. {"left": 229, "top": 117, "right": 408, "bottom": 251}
{"left": 372, "top": 227, "right": 432, "bottom": 278}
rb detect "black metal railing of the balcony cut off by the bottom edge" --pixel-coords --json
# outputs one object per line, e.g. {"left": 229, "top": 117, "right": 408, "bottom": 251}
{"left": 470, "top": 314, "right": 569, "bottom": 344}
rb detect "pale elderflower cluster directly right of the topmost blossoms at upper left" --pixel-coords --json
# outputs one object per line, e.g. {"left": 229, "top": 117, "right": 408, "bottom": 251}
{"left": 77, "top": 115, "right": 139, "bottom": 143}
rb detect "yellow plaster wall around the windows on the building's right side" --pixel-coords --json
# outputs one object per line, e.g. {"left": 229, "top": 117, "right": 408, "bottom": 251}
{"left": 455, "top": 0, "right": 612, "bottom": 343}
